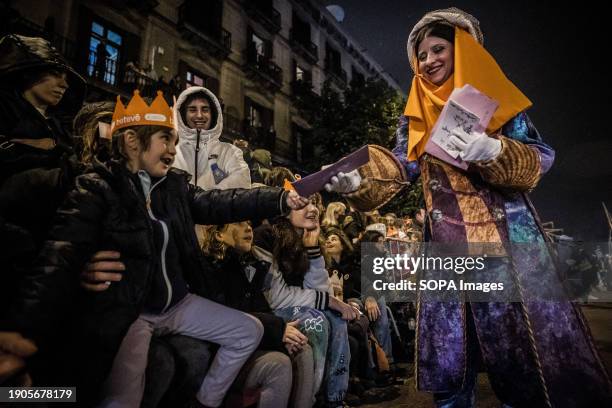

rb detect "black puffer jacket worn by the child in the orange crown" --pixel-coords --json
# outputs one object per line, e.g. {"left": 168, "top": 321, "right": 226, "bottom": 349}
{"left": 8, "top": 162, "right": 286, "bottom": 398}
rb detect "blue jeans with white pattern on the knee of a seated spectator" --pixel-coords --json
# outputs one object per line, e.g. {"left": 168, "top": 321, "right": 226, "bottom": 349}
{"left": 274, "top": 306, "right": 351, "bottom": 402}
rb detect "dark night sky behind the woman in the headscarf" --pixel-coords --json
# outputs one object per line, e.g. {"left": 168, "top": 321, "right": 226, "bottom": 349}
{"left": 325, "top": 0, "right": 612, "bottom": 241}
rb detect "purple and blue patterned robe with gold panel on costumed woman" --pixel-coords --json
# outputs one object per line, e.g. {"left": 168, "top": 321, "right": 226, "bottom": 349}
{"left": 393, "top": 112, "right": 612, "bottom": 408}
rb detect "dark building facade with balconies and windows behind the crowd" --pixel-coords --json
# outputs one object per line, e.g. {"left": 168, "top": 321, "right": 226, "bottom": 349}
{"left": 1, "top": 0, "right": 400, "bottom": 167}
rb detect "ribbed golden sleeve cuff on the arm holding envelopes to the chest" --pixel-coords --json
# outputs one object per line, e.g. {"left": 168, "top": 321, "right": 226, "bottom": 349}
{"left": 474, "top": 136, "right": 540, "bottom": 191}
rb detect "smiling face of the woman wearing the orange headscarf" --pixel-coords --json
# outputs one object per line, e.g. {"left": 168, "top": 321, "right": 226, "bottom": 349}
{"left": 417, "top": 35, "right": 455, "bottom": 86}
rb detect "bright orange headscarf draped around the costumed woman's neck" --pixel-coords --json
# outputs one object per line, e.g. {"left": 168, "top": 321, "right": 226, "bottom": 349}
{"left": 404, "top": 27, "right": 531, "bottom": 160}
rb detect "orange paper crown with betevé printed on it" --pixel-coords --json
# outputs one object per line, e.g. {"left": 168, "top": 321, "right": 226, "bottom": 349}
{"left": 110, "top": 90, "right": 174, "bottom": 134}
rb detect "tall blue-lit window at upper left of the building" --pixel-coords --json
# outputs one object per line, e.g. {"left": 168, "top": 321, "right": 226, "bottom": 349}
{"left": 87, "top": 21, "right": 123, "bottom": 85}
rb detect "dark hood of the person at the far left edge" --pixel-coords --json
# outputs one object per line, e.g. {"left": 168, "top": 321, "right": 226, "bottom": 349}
{"left": 0, "top": 34, "right": 86, "bottom": 112}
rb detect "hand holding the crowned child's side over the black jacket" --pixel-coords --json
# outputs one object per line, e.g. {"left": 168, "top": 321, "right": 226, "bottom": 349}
{"left": 81, "top": 251, "right": 125, "bottom": 292}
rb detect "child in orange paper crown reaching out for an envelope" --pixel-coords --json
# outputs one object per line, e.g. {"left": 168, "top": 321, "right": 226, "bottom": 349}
{"left": 5, "top": 91, "right": 308, "bottom": 407}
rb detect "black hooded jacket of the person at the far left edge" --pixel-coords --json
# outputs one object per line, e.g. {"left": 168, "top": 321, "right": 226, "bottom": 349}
{"left": 0, "top": 35, "right": 85, "bottom": 313}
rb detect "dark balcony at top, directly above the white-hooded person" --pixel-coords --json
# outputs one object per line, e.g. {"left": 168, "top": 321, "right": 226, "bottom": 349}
{"left": 178, "top": 3, "right": 232, "bottom": 58}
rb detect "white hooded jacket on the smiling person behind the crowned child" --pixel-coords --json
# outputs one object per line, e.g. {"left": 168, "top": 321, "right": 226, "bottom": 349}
{"left": 174, "top": 86, "right": 251, "bottom": 190}
